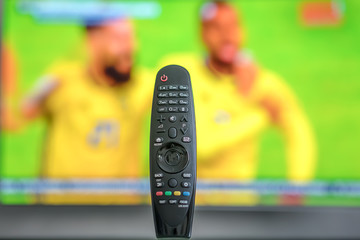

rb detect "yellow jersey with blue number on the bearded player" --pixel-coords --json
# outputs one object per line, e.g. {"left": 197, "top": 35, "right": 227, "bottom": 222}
{"left": 37, "top": 61, "right": 153, "bottom": 179}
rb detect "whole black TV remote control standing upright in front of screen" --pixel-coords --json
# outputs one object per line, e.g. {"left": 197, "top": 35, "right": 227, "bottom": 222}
{"left": 150, "top": 65, "right": 196, "bottom": 238}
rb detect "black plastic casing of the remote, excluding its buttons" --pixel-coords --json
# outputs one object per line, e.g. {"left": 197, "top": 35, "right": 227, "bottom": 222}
{"left": 150, "top": 65, "right": 196, "bottom": 238}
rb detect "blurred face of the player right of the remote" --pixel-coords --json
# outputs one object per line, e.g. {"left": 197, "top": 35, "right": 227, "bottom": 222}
{"left": 202, "top": 6, "right": 241, "bottom": 64}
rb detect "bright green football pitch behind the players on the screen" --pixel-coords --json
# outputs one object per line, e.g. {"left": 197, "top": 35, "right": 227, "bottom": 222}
{"left": 0, "top": 0, "right": 360, "bottom": 204}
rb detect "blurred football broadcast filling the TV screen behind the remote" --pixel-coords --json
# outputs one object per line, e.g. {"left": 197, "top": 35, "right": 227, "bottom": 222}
{"left": 0, "top": 0, "right": 360, "bottom": 206}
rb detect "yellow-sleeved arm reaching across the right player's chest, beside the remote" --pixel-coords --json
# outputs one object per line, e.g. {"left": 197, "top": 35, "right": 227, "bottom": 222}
{"left": 195, "top": 105, "right": 269, "bottom": 161}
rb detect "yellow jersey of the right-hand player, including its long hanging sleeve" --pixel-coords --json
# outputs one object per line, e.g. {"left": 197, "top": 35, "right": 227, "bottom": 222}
{"left": 162, "top": 54, "right": 315, "bottom": 181}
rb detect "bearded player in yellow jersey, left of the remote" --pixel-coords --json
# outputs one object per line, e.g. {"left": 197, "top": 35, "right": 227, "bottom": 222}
{"left": 4, "top": 19, "right": 153, "bottom": 203}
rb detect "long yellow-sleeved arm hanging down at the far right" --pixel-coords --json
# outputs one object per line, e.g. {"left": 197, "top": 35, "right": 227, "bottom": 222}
{"left": 262, "top": 73, "right": 316, "bottom": 182}
